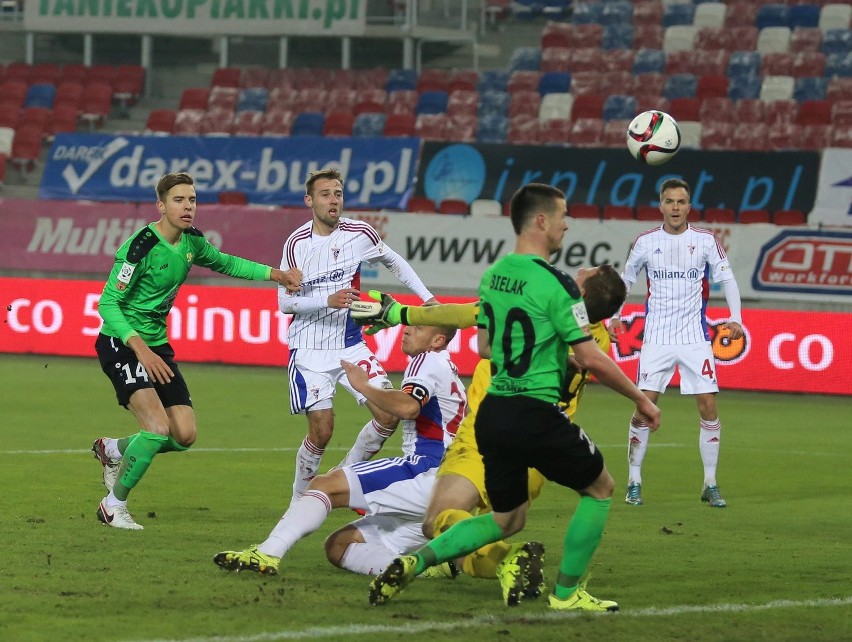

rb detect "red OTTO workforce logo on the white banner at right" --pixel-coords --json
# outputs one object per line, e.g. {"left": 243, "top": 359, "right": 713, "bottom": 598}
{"left": 751, "top": 230, "right": 852, "bottom": 296}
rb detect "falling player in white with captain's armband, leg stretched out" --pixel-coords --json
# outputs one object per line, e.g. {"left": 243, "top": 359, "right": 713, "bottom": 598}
{"left": 213, "top": 326, "right": 467, "bottom": 575}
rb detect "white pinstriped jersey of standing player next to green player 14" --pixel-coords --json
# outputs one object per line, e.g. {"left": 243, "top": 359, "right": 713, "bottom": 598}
{"left": 278, "top": 218, "right": 389, "bottom": 350}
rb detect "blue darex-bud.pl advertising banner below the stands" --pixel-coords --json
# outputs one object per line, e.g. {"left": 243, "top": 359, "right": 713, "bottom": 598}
{"left": 39, "top": 134, "right": 419, "bottom": 208}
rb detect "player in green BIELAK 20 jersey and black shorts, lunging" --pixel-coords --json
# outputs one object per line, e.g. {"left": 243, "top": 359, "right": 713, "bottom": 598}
{"left": 370, "top": 183, "right": 660, "bottom": 611}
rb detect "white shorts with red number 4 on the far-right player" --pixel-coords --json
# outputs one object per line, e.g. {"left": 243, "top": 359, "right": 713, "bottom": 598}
{"left": 636, "top": 342, "right": 719, "bottom": 395}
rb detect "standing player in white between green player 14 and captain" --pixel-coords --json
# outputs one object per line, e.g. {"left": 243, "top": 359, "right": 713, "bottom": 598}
{"left": 278, "top": 169, "right": 434, "bottom": 500}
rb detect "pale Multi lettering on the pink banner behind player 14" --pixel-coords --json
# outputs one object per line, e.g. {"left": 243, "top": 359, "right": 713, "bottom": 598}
{"left": 27, "top": 216, "right": 222, "bottom": 256}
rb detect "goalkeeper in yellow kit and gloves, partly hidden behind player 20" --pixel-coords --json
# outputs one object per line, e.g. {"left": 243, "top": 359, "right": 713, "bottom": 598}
{"left": 352, "top": 265, "right": 624, "bottom": 606}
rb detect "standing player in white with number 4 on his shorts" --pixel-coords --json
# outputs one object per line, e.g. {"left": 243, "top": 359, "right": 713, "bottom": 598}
{"left": 609, "top": 179, "right": 743, "bottom": 508}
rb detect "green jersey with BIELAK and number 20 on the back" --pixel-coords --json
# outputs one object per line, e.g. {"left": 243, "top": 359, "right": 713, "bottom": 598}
{"left": 477, "top": 254, "right": 592, "bottom": 403}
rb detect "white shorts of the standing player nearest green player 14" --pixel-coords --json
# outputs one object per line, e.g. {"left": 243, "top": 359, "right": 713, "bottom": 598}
{"left": 287, "top": 342, "right": 393, "bottom": 415}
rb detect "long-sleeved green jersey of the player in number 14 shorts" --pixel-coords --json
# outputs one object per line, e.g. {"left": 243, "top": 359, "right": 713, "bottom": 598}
{"left": 98, "top": 223, "right": 272, "bottom": 346}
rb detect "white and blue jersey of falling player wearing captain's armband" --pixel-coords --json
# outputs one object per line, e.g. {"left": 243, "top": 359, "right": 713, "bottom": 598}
{"left": 400, "top": 350, "right": 467, "bottom": 459}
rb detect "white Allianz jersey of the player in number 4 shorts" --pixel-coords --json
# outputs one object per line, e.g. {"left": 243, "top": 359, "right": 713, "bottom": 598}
{"left": 621, "top": 225, "right": 734, "bottom": 345}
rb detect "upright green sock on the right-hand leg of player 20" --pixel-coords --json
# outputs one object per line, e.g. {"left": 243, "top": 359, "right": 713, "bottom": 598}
{"left": 554, "top": 497, "right": 612, "bottom": 600}
